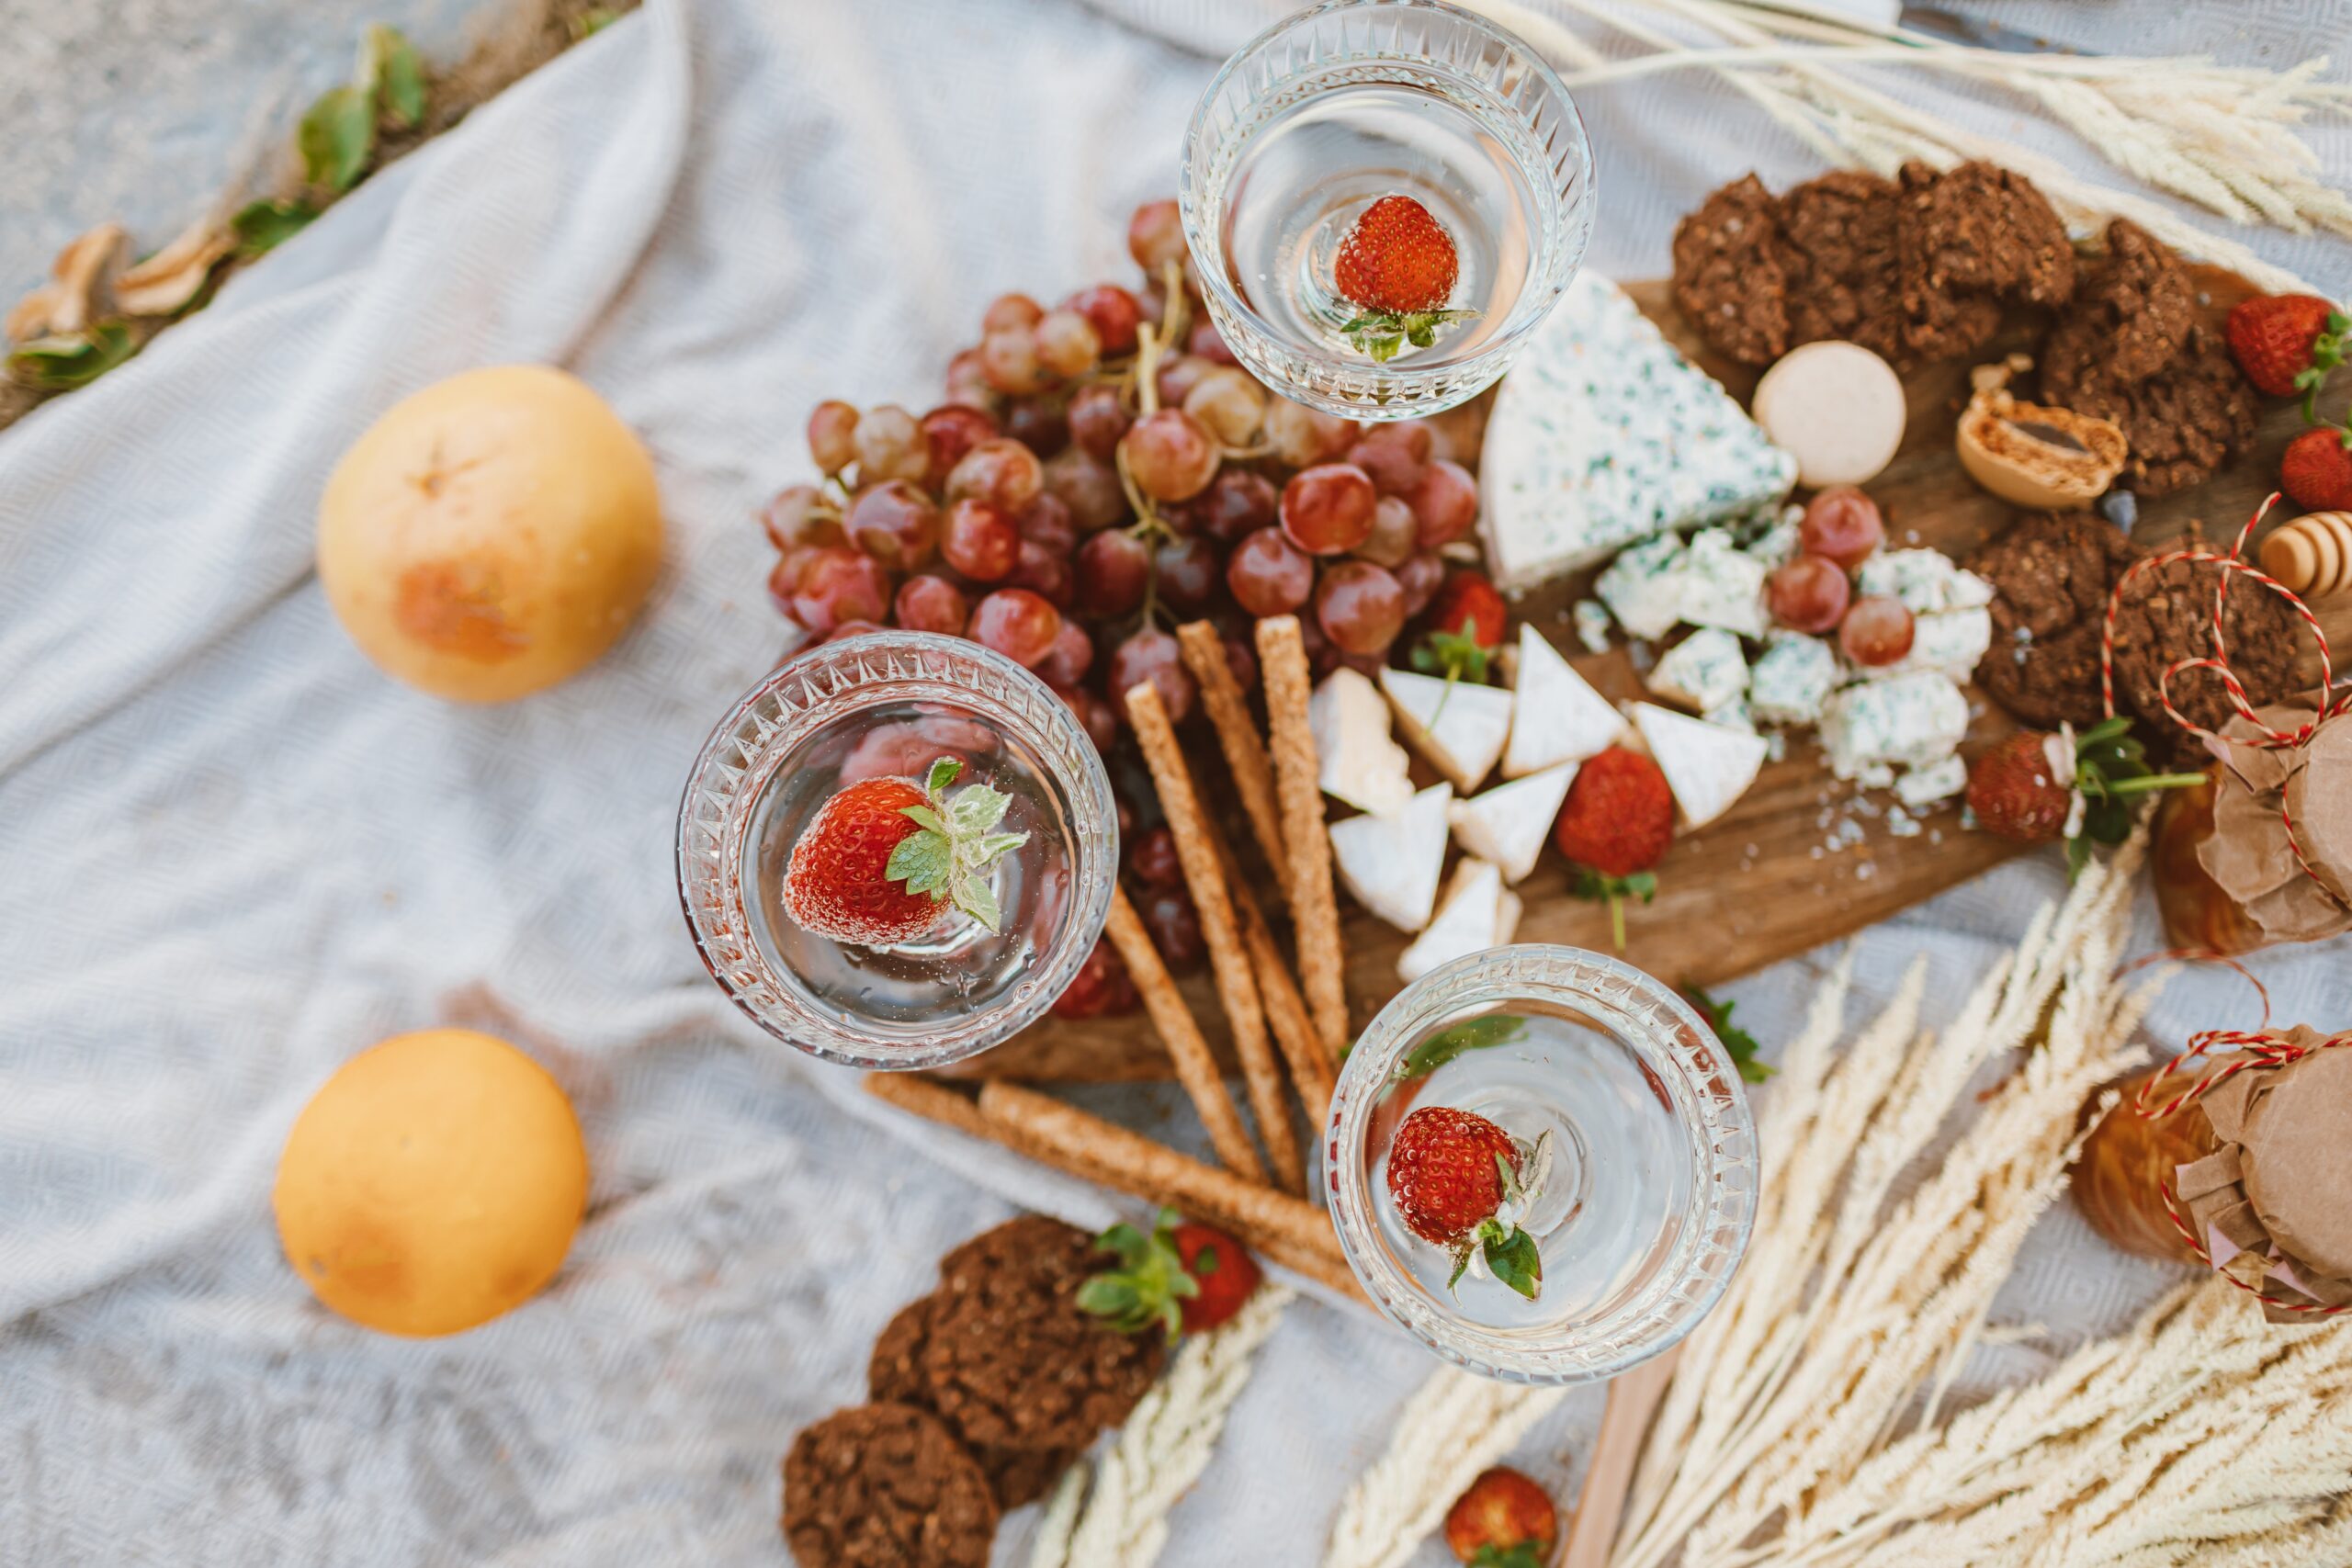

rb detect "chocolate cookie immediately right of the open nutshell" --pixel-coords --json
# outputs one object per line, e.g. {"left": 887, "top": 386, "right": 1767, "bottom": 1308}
{"left": 2041, "top": 324, "right": 2256, "bottom": 496}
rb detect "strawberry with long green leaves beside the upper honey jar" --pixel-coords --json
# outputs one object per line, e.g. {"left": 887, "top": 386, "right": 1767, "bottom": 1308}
{"left": 1969, "top": 717, "right": 2206, "bottom": 872}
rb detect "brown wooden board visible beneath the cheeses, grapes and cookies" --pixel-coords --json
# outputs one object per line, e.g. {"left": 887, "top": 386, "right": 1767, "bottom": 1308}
{"left": 959, "top": 268, "right": 2352, "bottom": 1081}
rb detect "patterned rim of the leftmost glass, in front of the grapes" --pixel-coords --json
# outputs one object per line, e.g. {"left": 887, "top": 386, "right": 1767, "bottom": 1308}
{"left": 675, "top": 630, "right": 1120, "bottom": 1069}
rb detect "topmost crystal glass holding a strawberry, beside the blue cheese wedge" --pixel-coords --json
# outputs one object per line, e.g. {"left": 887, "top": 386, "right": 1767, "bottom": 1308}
{"left": 1179, "top": 0, "right": 1595, "bottom": 419}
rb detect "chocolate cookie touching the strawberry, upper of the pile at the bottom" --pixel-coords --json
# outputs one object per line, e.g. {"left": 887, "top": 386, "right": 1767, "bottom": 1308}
{"left": 917, "top": 1215, "right": 1167, "bottom": 1450}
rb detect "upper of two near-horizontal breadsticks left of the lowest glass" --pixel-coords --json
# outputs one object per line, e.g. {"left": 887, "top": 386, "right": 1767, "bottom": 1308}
{"left": 981, "top": 1079, "right": 1345, "bottom": 1267}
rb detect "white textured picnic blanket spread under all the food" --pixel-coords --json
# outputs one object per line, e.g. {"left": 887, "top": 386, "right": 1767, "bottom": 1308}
{"left": 0, "top": 0, "right": 2352, "bottom": 1568}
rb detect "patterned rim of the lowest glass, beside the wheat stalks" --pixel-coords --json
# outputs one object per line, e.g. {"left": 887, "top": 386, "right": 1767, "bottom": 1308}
{"left": 1324, "top": 942, "right": 1761, "bottom": 1384}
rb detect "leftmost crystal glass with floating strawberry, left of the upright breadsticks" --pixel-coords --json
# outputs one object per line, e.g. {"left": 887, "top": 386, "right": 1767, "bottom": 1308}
{"left": 677, "top": 630, "right": 1120, "bottom": 1067}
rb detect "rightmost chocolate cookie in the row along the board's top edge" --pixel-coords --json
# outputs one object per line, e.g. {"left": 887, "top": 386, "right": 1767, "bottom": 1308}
{"left": 1895, "top": 163, "right": 2075, "bottom": 306}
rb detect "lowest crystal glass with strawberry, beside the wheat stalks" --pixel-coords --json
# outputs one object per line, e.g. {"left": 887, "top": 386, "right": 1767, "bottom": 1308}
{"left": 1327, "top": 945, "right": 1757, "bottom": 1382}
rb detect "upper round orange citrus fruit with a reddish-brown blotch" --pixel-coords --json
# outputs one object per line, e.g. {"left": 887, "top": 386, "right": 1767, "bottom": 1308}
{"left": 318, "top": 365, "right": 661, "bottom": 703}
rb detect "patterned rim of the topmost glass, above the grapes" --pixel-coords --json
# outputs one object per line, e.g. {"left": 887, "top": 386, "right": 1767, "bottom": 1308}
{"left": 1176, "top": 0, "right": 1597, "bottom": 419}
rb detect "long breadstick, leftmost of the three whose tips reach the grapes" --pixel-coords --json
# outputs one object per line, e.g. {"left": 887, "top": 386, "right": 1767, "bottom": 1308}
{"left": 1126, "top": 682, "right": 1307, "bottom": 1192}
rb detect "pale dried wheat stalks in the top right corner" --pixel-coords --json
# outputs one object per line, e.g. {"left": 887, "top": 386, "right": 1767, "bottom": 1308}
{"left": 1470, "top": 0, "right": 2352, "bottom": 291}
